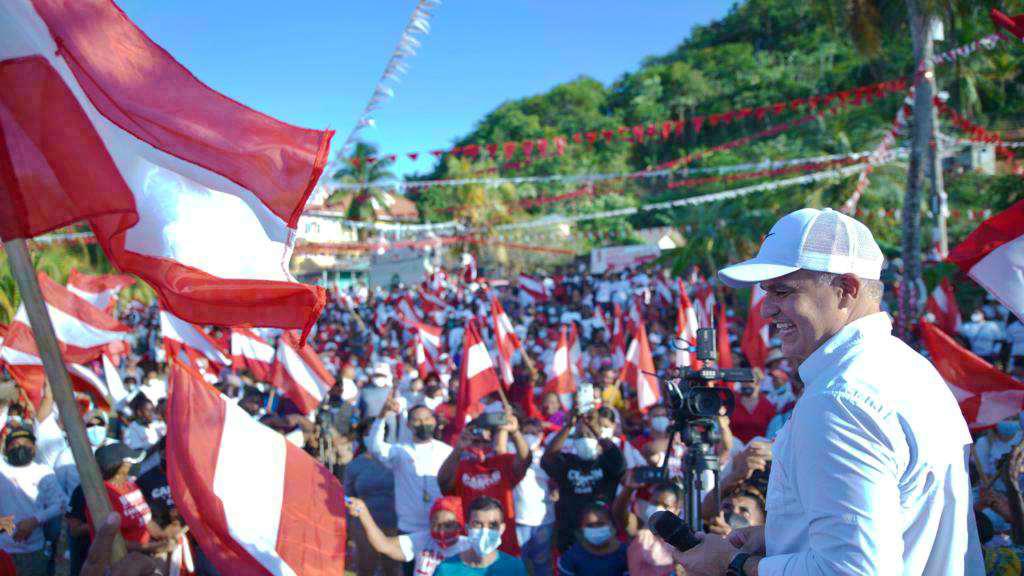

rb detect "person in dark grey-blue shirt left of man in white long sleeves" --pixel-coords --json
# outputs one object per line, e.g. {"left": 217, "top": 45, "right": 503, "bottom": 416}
{"left": 343, "top": 422, "right": 406, "bottom": 576}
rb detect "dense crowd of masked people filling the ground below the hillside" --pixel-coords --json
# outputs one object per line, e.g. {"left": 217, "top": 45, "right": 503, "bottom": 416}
{"left": 0, "top": 256, "right": 1024, "bottom": 576}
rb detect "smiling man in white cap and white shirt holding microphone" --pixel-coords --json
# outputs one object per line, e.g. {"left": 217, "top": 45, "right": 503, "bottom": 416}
{"left": 678, "top": 208, "right": 985, "bottom": 576}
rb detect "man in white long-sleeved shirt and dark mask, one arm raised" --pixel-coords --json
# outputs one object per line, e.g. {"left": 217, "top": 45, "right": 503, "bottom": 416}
{"left": 367, "top": 399, "right": 452, "bottom": 534}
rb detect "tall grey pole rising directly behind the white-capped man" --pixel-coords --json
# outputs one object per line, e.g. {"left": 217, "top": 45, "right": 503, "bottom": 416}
{"left": 898, "top": 0, "right": 941, "bottom": 339}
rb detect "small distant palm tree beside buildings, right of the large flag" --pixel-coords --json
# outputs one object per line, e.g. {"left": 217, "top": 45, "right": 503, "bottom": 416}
{"left": 328, "top": 142, "right": 395, "bottom": 220}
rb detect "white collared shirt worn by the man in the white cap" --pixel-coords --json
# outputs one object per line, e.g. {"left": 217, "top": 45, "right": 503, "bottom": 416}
{"left": 758, "top": 313, "right": 985, "bottom": 576}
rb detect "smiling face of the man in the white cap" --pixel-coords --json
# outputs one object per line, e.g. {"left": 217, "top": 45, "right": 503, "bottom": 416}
{"left": 761, "top": 270, "right": 845, "bottom": 362}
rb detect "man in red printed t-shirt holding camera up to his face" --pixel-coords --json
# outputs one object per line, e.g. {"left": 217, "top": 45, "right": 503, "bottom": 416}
{"left": 437, "top": 406, "right": 534, "bottom": 557}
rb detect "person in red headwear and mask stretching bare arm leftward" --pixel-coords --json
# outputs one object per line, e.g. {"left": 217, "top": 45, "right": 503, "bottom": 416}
{"left": 345, "top": 496, "right": 469, "bottom": 576}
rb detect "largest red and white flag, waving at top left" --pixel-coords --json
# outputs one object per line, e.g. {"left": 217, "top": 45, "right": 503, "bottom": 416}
{"left": 0, "top": 0, "right": 332, "bottom": 331}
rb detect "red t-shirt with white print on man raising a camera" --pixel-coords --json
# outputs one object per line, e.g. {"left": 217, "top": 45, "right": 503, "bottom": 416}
{"left": 455, "top": 451, "right": 522, "bottom": 557}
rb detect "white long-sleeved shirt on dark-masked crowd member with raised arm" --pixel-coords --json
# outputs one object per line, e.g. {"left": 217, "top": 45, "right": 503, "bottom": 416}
{"left": 369, "top": 418, "right": 452, "bottom": 533}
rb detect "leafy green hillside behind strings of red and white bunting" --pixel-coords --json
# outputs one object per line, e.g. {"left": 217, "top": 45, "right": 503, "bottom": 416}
{"left": 416, "top": 0, "right": 1024, "bottom": 263}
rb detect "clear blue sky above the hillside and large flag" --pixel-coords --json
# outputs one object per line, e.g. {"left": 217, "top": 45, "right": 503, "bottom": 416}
{"left": 117, "top": 0, "right": 732, "bottom": 173}
